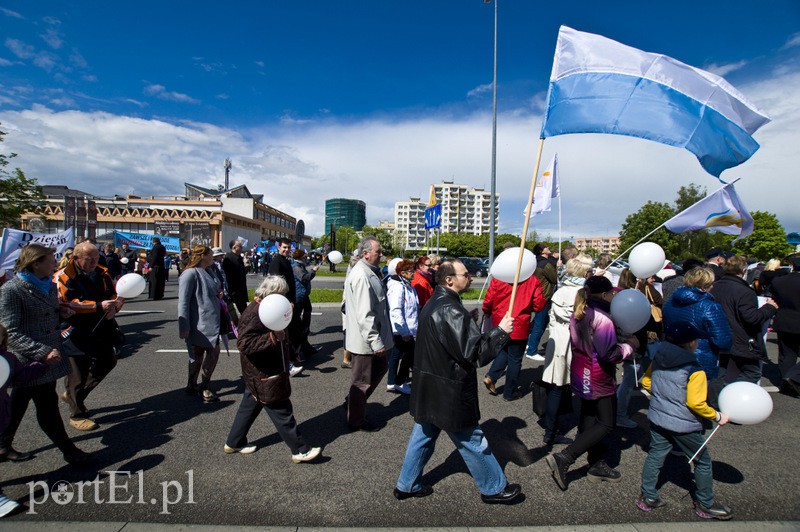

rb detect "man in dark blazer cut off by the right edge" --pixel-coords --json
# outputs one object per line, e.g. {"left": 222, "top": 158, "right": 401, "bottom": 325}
{"left": 772, "top": 257, "right": 800, "bottom": 397}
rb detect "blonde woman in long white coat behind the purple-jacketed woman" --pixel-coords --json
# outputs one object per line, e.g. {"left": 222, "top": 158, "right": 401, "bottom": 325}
{"left": 542, "top": 253, "right": 592, "bottom": 445}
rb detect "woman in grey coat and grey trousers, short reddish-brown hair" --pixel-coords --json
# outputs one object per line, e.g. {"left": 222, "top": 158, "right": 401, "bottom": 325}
{"left": 178, "top": 246, "right": 222, "bottom": 403}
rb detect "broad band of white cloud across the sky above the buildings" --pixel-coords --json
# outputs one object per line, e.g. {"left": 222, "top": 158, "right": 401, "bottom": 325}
{"left": 0, "top": 65, "right": 800, "bottom": 238}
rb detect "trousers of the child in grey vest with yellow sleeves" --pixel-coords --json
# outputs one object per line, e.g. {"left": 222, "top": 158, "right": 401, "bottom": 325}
{"left": 642, "top": 425, "right": 714, "bottom": 508}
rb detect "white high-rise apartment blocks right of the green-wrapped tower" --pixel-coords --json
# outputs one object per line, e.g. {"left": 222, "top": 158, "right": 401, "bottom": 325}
{"left": 394, "top": 181, "right": 500, "bottom": 251}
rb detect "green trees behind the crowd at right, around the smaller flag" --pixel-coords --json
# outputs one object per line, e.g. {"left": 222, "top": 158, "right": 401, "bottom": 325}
{"left": 619, "top": 183, "right": 792, "bottom": 261}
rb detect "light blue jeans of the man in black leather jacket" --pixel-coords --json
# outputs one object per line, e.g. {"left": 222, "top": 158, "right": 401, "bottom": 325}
{"left": 397, "top": 423, "right": 508, "bottom": 495}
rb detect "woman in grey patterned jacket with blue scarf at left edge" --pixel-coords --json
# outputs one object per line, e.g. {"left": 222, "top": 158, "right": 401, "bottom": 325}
{"left": 0, "top": 244, "right": 89, "bottom": 463}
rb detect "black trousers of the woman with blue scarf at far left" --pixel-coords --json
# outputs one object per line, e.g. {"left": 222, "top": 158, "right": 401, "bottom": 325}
{"left": 0, "top": 381, "right": 75, "bottom": 453}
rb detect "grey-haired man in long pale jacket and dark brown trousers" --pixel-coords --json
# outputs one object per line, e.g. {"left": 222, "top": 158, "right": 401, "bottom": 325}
{"left": 344, "top": 236, "right": 394, "bottom": 432}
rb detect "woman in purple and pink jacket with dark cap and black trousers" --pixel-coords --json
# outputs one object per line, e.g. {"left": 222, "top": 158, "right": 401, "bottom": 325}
{"left": 545, "top": 276, "right": 639, "bottom": 490}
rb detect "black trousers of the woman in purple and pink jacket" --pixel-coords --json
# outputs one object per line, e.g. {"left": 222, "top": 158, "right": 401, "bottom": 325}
{"left": 562, "top": 394, "right": 617, "bottom": 466}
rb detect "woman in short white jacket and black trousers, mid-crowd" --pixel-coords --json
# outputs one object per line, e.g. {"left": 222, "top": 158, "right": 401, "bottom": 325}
{"left": 386, "top": 259, "right": 419, "bottom": 395}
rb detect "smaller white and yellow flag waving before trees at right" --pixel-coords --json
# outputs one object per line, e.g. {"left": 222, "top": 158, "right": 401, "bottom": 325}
{"left": 664, "top": 183, "right": 753, "bottom": 242}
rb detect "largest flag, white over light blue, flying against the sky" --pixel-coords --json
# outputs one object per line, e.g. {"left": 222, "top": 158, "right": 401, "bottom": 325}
{"left": 541, "top": 26, "right": 770, "bottom": 177}
